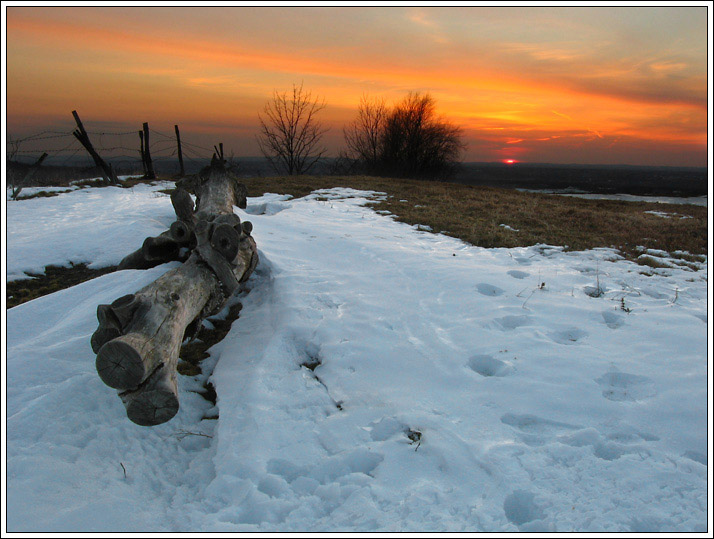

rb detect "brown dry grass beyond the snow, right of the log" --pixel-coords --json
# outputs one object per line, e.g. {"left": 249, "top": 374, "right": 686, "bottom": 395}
{"left": 243, "top": 176, "right": 707, "bottom": 258}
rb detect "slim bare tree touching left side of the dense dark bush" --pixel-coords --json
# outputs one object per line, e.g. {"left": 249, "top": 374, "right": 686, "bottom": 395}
{"left": 342, "top": 95, "right": 387, "bottom": 174}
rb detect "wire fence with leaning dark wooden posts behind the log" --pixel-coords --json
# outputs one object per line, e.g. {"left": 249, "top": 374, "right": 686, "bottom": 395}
{"left": 6, "top": 122, "right": 214, "bottom": 179}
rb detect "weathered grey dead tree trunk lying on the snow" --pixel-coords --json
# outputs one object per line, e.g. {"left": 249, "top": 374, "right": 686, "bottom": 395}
{"left": 91, "top": 162, "right": 258, "bottom": 426}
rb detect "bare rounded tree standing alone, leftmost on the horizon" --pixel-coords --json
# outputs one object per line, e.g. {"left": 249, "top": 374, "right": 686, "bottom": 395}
{"left": 257, "top": 84, "right": 327, "bottom": 175}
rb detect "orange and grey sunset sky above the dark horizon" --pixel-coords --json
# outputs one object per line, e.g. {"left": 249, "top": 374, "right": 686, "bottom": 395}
{"left": 6, "top": 3, "right": 709, "bottom": 166}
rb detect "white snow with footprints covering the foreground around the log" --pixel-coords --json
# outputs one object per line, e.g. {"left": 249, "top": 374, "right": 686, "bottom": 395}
{"left": 5, "top": 180, "right": 708, "bottom": 532}
